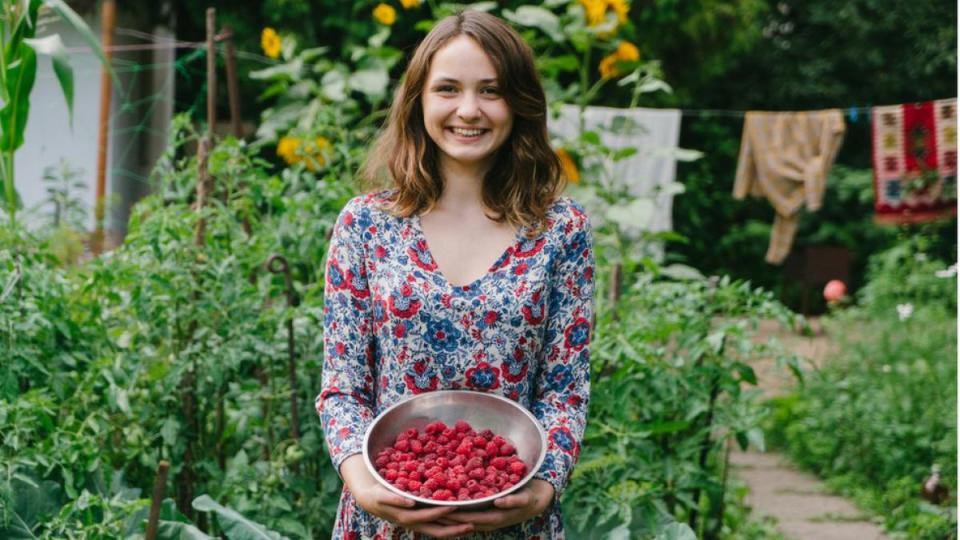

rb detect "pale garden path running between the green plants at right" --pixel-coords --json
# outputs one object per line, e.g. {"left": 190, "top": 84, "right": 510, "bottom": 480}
{"left": 730, "top": 319, "right": 887, "bottom": 540}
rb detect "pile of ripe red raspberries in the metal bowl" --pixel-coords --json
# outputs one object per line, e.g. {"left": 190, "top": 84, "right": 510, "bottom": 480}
{"left": 375, "top": 420, "right": 527, "bottom": 501}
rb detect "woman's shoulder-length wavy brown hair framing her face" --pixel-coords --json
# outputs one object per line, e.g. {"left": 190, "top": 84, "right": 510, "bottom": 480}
{"left": 360, "top": 11, "right": 563, "bottom": 236}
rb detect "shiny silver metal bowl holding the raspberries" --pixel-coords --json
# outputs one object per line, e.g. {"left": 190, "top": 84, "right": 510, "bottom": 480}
{"left": 363, "top": 390, "right": 547, "bottom": 509}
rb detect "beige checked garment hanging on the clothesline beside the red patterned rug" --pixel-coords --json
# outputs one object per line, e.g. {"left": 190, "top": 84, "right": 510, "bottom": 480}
{"left": 733, "top": 109, "right": 846, "bottom": 264}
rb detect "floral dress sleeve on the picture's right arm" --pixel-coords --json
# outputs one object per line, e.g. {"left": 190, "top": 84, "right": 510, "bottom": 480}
{"left": 532, "top": 204, "right": 594, "bottom": 498}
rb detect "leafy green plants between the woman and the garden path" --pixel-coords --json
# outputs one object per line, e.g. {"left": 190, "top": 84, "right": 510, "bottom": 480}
{"left": 564, "top": 272, "right": 797, "bottom": 537}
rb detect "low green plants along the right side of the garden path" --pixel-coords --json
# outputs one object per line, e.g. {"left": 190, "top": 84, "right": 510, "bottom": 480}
{"left": 769, "top": 235, "right": 957, "bottom": 538}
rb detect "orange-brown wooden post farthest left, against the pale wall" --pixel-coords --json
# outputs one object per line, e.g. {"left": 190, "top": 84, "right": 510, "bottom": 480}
{"left": 91, "top": 0, "right": 117, "bottom": 255}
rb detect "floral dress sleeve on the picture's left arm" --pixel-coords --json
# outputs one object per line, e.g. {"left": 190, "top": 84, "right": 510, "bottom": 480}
{"left": 316, "top": 199, "right": 375, "bottom": 472}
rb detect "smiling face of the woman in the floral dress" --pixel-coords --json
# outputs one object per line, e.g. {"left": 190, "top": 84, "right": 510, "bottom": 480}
{"left": 423, "top": 35, "right": 513, "bottom": 174}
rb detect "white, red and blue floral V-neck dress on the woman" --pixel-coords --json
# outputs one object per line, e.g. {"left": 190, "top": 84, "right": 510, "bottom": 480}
{"left": 316, "top": 192, "right": 594, "bottom": 540}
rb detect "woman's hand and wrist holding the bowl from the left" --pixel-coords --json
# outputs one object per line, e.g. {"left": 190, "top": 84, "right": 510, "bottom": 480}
{"left": 340, "top": 454, "right": 475, "bottom": 538}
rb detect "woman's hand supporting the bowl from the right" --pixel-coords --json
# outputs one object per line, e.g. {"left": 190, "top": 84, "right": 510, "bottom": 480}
{"left": 441, "top": 479, "right": 554, "bottom": 531}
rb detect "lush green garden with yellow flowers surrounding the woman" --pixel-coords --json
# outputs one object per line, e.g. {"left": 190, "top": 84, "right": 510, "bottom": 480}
{"left": 0, "top": 0, "right": 957, "bottom": 540}
